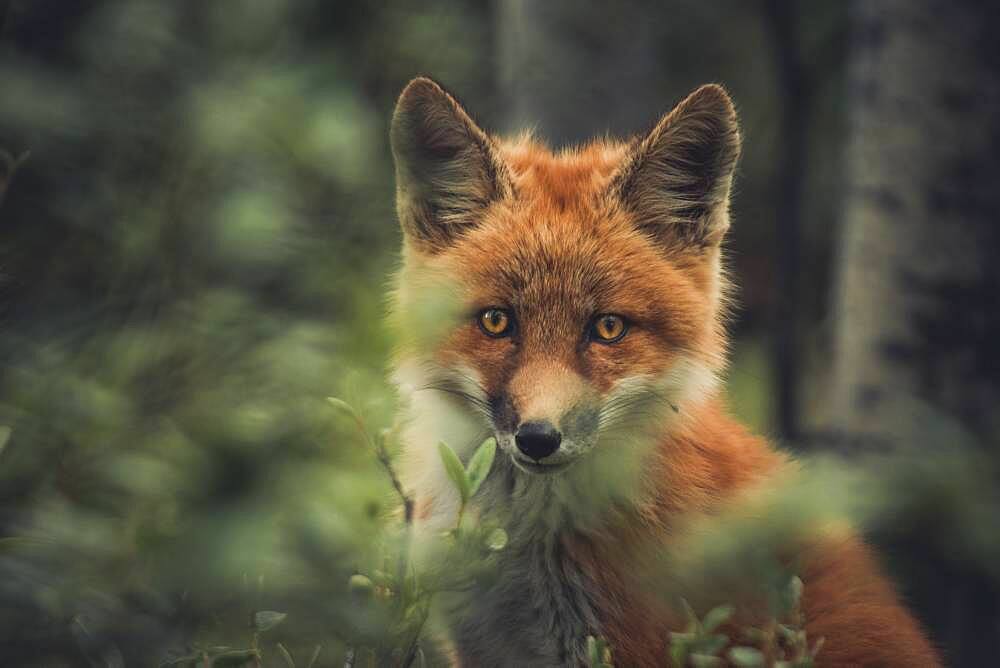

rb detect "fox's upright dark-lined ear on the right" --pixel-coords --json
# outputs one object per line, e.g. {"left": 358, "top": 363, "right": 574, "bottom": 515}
{"left": 611, "top": 84, "right": 740, "bottom": 250}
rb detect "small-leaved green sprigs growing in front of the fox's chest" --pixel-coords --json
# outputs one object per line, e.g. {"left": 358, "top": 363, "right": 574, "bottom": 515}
{"left": 298, "top": 397, "right": 823, "bottom": 668}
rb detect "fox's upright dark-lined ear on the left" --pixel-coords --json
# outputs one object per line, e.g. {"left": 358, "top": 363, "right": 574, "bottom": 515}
{"left": 390, "top": 77, "right": 511, "bottom": 252}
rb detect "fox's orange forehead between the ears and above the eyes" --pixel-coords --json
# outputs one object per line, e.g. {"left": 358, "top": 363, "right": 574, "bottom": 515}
{"left": 418, "top": 138, "right": 710, "bottom": 343}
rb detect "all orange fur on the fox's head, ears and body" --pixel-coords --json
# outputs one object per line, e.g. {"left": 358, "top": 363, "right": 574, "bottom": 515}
{"left": 393, "top": 79, "right": 939, "bottom": 666}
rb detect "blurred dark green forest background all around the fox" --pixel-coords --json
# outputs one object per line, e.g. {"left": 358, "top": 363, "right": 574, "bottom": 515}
{"left": 0, "top": 0, "right": 1000, "bottom": 666}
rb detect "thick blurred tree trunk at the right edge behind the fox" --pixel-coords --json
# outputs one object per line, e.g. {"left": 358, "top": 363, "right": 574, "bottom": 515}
{"left": 832, "top": 0, "right": 1000, "bottom": 666}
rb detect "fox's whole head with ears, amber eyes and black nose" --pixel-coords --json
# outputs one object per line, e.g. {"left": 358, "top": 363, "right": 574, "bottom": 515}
{"left": 391, "top": 78, "right": 740, "bottom": 494}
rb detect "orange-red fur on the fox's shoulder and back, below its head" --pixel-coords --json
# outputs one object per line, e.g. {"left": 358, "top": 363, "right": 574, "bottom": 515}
{"left": 573, "top": 404, "right": 941, "bottom": 668}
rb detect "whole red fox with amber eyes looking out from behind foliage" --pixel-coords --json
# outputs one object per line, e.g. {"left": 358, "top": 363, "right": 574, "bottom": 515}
{"left": 391, "top": 78, "right": 939, "bottom": 667}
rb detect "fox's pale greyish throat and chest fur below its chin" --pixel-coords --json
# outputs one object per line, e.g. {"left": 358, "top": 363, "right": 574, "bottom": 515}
{"left": 454, "top": 412, "right": 688, "bottom": 666}
